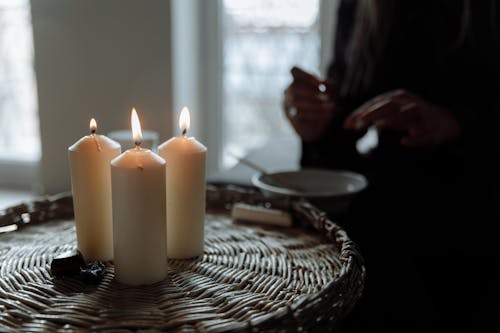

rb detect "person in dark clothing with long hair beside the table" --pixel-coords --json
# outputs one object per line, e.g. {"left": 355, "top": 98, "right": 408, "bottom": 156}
{"left": 284, "top": 0, "right": 500, "bottom": 332}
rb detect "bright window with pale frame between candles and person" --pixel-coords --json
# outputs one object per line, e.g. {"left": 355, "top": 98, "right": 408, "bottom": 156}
{"left": 171, "top": 0, "right": 338, "bottom": 176}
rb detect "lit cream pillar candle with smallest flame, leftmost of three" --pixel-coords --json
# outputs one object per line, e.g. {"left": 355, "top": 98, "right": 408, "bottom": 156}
{"left": 68, "top": 118, "right": 121, "bottom": 261}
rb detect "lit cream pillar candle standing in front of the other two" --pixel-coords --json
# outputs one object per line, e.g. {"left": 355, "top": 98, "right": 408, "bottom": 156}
{"left": 111, "top": 109, "right": 167, "bottom": 285}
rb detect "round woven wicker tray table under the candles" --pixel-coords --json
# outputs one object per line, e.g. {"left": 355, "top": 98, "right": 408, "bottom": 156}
{"left": 0, "top": 186, "right": 364, "bottom": 332}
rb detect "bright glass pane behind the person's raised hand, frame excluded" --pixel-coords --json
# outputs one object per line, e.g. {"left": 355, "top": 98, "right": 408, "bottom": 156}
{"left": 222, "top": 0, "right": 320, "bottom": 168}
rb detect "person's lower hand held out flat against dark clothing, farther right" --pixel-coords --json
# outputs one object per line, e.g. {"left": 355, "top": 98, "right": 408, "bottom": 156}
{"left": 344, "top": 89, "right": 460, "bottom": 147}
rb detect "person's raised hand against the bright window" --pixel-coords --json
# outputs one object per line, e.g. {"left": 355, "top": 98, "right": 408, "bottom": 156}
{"left": 283, "top": 67, "right": 335, "bottom": 142}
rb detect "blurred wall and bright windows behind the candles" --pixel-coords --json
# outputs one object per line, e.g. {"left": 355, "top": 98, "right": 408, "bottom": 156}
{"left": 0, "top": 0, "right": 337, "bottom": 203}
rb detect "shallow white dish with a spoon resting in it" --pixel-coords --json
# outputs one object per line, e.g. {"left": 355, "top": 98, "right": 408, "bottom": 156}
{"left": 252, "top": 169, "right": 368, "bottom": 198}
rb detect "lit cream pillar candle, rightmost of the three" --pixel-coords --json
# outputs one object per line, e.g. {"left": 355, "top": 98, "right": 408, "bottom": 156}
{"left": 158, "top": 108, "right": 207, "bottom": 259}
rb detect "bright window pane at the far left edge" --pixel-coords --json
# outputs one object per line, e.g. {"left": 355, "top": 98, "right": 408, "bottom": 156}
{"left": 0, "top": 0, "right": 40, "bottom": 160}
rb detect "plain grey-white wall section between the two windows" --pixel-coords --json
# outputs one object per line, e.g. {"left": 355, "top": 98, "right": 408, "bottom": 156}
{"left": 31, "top": 0, "right": 175, "bottom": 193}
